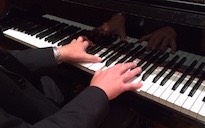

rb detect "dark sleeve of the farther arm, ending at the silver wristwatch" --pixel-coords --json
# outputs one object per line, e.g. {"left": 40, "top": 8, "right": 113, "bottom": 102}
{"left": 9, "top": 47, "right": 57, "bottom": 71}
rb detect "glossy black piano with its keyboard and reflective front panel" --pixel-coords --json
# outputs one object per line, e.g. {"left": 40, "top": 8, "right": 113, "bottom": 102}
{"left": 0, "top": 0, "right": 205, "bottom": 128}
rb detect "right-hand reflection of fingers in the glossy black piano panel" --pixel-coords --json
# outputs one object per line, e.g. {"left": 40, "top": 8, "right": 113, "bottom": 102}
{"left": 139, "top": 26, "right": 176, "bottom": 53}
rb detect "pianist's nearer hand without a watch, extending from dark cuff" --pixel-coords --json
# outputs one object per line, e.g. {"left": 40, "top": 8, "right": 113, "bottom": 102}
{"left": 90, "top": 62, "right": 142, "bottom": 100}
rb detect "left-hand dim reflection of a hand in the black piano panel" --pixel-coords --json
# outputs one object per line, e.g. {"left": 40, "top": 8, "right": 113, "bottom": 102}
{"left": 96, "top": 13, "right": 126, "bottom": 40}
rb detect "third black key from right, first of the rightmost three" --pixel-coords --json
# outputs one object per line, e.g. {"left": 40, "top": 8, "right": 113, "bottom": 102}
{"left": 172, "top": 60, "right": 198, "bottom": 90}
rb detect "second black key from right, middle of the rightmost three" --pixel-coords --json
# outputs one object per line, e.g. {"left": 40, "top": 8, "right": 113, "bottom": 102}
{"left": 180, "top": 63, "right": 205, "bottom": 93}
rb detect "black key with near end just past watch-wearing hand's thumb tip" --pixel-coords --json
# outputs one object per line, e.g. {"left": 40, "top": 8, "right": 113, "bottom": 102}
{"left": 105, "top": 43, "right": 134, "bottom": 66}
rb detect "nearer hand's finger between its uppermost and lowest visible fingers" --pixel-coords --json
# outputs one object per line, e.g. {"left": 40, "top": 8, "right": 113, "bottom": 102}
{"left": 122, "top": 67, "right": 142, "bottom": 82}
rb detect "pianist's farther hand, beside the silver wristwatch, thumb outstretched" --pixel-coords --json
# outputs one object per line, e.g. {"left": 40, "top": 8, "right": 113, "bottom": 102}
{"left": 58, "top": 36, "right": 101, "bottom": 62}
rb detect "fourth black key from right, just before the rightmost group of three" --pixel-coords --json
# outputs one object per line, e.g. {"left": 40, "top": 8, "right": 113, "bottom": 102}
{"left": 160, "top": 57, "right": 187, "bottom": 86}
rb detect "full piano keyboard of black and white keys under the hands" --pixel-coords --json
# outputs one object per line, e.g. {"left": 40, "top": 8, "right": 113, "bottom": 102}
{"left": 2, "top": 15, "right": 205, "bottom": 124}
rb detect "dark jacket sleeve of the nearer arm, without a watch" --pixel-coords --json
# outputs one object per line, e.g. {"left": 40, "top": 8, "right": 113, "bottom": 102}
{"left": 34, "top": 87, "right": 109, "bottom": 128}
